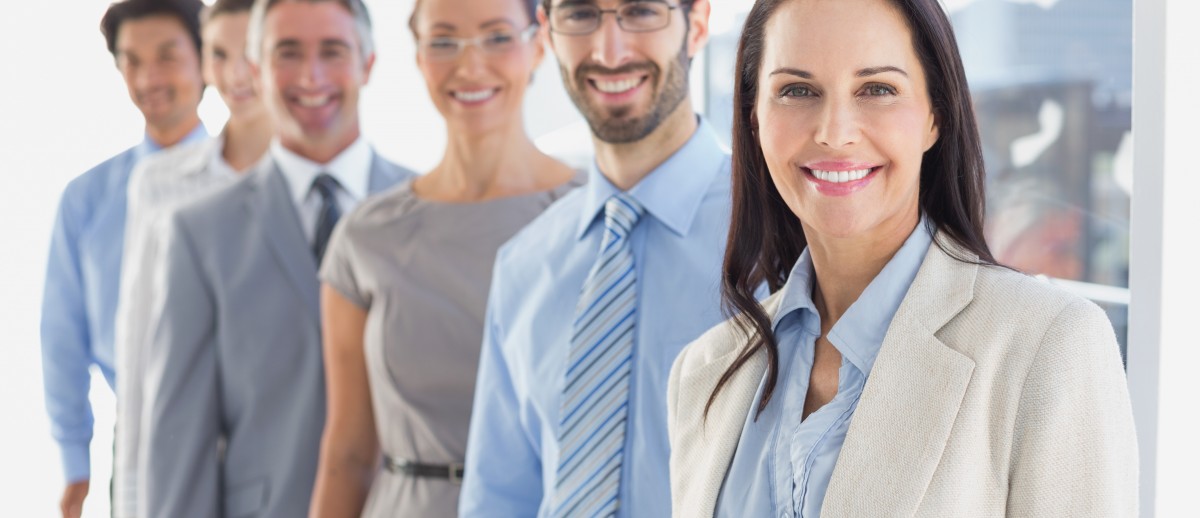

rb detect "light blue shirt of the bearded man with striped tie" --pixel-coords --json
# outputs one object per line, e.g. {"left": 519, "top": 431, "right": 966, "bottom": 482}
{"left": 460, "top": 121, "right": 731, "bottom": 518}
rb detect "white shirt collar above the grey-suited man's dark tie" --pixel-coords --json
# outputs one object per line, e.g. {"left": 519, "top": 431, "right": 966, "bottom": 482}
{"left": 270, "top": 137, "right": 372, "bottom": 203}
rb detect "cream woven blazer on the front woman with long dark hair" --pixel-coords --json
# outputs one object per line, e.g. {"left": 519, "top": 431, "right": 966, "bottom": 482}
{"left": 667, "top": 235, "right": 1138, "bottom": 518}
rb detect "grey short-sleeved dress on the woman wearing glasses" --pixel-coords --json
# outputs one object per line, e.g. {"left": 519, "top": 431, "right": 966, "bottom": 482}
{"left": 320, "top": 174, "right": 586, "bottom": 517}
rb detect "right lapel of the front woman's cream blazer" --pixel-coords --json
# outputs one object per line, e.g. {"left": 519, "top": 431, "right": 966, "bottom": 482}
{"left": 823, "top": 234, "right": 979, "bottom": 517}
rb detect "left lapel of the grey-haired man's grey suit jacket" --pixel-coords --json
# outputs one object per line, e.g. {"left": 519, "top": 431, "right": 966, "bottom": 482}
{"left": 250, "top": 159, "right": 320, "bottom": 319}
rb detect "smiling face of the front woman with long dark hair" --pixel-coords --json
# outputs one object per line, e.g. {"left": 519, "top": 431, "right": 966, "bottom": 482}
{"left": 754, "top": 0, "right": 937, "bottom": 239}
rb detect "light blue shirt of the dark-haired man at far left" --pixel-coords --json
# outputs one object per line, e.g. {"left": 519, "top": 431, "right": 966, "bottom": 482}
{"left": 42, "top": 125, "right": 208, "bottom": 482}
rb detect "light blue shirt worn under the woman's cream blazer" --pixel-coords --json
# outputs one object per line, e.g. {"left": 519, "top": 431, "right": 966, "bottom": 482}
{"left": 716, "top": 219, "right": 932, "bottom": 518}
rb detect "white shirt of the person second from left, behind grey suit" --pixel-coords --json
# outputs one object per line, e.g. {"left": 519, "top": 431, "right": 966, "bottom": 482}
{"left": 113, "top": 133, "right": 250, "bottom": 518}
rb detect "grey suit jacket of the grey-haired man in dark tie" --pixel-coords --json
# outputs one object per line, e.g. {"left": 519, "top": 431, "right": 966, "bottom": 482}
{"left": 139, "top": 156, "right": 412, "bottom": 518}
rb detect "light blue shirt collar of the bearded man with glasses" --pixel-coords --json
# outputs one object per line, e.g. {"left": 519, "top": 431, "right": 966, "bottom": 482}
{"left": 575, "top": 118, "right": 728, "bottom": 239}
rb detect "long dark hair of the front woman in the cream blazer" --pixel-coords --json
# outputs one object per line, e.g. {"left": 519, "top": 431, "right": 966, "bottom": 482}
{"left": 704, "top": 0, "right": 996, "bottom": 415}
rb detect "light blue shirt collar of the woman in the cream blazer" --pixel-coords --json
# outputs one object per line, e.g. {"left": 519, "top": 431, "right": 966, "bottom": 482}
{"left": 772, "top": 217, "right": 934, "bottom": 375}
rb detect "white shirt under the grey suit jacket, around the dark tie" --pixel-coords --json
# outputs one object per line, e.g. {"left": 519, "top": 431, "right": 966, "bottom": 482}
{"left": 271, "top": 137, "right": 372, "bottom": 243}
